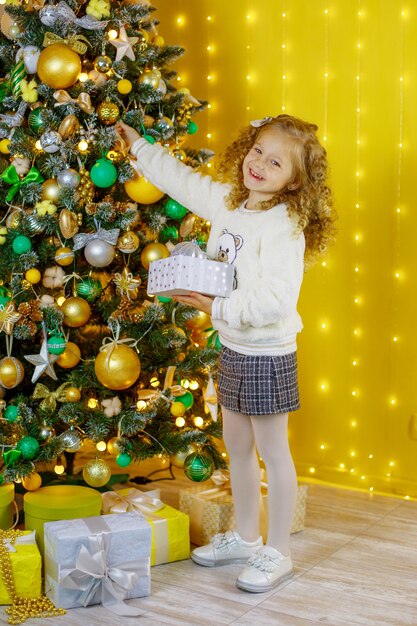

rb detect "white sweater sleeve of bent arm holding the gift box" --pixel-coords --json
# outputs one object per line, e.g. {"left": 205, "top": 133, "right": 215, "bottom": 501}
{"left": 213, "top": 219, "right": 305, "bottom": 329}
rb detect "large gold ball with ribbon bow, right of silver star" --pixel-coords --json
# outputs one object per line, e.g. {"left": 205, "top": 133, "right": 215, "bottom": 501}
{"left": 94, "top": 344, "right": 140, "bottom": 391}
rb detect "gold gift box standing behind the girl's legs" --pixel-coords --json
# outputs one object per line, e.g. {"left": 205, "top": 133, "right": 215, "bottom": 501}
{"left": 179, "top": 470, "right": 307, "bottom": 546}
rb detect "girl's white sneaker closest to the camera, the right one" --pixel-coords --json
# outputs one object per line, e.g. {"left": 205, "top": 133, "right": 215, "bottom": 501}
{"left": 236, "top": 546, "right": 293, "bottom": 593}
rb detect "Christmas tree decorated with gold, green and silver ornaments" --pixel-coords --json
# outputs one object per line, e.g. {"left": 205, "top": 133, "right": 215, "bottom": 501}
{"left": 0, "top": 0, "right": 224, "bottom": 489}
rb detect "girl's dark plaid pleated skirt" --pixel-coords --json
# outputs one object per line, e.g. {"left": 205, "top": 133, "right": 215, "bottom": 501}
{"left": 218, "top": 347, "right": 300, "bottom": 415}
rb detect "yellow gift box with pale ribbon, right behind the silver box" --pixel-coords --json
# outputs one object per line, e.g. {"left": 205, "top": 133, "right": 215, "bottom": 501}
{"left": 102, "top": 489, "right": 190, "bottom": 565}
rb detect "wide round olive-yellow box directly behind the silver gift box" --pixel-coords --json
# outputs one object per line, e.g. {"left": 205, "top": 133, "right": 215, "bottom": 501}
{"left": 23, "top": 485, "right": 101, "bottom": 554}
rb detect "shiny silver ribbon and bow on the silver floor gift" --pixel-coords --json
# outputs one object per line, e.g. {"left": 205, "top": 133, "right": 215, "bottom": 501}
{"left": 59, "top": 517, "right": 150, "bottom": 616}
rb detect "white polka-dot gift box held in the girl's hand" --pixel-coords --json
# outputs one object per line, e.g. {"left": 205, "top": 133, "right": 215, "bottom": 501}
{"left": 148, "top": 255, "right": 234, "bottom": 298}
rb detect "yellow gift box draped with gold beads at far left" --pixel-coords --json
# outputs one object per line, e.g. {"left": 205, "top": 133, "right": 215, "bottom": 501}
{"left": 0, "top": 531, "right": 42, "bottom": 604}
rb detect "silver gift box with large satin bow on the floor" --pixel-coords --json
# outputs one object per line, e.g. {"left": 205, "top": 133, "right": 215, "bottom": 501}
{"left": 44, "top": 513, "right": 152, "bottom": 615}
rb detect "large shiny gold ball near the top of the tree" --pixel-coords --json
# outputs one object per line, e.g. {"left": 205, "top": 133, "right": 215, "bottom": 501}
{"left": 36, "top": 43, "right": 81, "bottom": 89}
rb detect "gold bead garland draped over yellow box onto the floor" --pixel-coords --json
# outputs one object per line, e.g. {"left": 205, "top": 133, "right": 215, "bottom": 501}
{"left": 0, "top": 530, "right": 66, "bottom": 624}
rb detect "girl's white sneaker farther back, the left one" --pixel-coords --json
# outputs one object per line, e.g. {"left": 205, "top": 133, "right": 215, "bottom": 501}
{"left": 191, "top": 530, "right": 262, "bottom": 567}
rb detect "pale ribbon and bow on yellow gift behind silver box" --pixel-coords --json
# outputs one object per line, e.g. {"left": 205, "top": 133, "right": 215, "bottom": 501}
{"left": 102, "top": 489, "right": 169, "bottom": 563}
